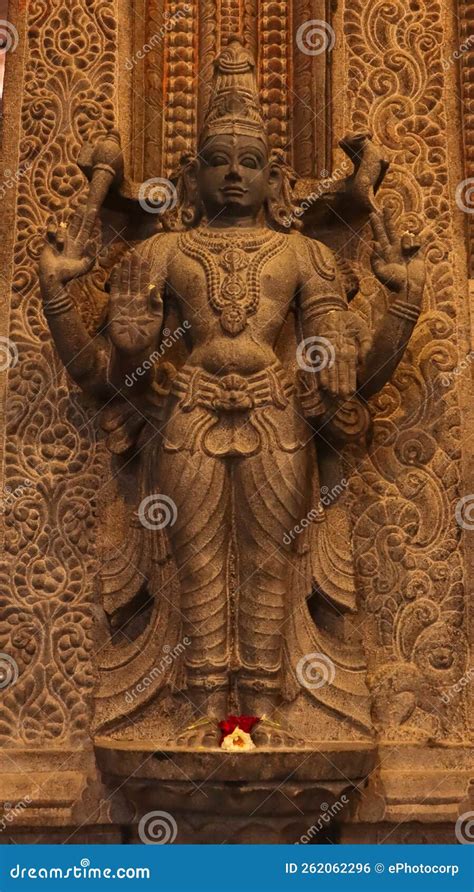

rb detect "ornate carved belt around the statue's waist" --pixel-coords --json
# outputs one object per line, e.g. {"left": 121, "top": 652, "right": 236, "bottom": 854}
{"left": 172, "top": 364, "right": 294, "bottom": 412}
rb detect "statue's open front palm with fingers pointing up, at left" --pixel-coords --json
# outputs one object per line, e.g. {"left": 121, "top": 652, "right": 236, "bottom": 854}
{"left": 108, "top": 252, "right": 163, "bottom": 355}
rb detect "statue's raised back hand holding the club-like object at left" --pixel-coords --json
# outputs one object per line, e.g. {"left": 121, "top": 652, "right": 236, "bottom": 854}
{"left": 39, "top": 205, "right": 98, "bottom": 301}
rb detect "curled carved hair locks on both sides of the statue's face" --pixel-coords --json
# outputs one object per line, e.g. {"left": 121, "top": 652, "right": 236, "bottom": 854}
{"left": 162, "top": 149, "right": 302, "bottom": 232}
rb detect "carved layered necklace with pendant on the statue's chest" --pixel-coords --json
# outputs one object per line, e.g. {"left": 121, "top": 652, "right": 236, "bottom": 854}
{"left": 179, "top": 228, "right": 287, "bottom": 337}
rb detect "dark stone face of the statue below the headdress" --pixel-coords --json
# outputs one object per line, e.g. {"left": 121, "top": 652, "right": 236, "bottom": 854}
{"left": 196, "top": 134, "right": 270, "bottom": 222}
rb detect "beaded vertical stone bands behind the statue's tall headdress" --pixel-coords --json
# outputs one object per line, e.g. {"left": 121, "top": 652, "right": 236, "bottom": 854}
{"left": 127, "top": 0, "right": 335, "bottom": 179}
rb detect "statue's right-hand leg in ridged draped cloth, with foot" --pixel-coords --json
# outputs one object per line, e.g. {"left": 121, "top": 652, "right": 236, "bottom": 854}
{"left": 233, "top": 446, "right": 313, "bottom": 745}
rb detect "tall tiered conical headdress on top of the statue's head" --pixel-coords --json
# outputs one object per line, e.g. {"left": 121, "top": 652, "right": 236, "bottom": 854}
{"left": 199, "top": 37, "right": 268, "bottom": 146}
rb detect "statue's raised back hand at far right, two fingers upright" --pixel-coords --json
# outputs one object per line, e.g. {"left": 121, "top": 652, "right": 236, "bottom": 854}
{"left": 370, "top": 208, "right": 426, "bottom": 306}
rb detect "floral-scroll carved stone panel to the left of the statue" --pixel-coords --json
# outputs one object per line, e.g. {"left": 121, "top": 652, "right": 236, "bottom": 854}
{"left": 0, "top": 0, "right": 117, "bottom": 823}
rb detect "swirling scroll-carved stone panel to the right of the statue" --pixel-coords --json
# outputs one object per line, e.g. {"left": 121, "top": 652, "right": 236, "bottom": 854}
{"left": 345, "top": 2, "right": 469, "bottom": 741}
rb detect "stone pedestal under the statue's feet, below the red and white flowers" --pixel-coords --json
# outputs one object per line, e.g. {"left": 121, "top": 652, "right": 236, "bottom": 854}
{"left": 96, "top": 739, "right": 375, "bottom": 844}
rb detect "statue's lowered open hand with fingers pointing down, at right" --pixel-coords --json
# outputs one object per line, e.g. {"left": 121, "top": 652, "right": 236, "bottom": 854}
{"left": 318, "top": 310, "right": 371, "bottom": 399}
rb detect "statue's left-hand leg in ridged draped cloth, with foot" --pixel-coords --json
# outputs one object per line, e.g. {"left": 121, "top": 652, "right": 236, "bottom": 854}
{"left": 157, "top": 452, "right": 230, "bottom": 745}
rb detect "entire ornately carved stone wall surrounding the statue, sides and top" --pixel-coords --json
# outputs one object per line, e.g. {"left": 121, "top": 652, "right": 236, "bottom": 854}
{"left": 0, "top": 0, "right": 474, "bottom": 840}
